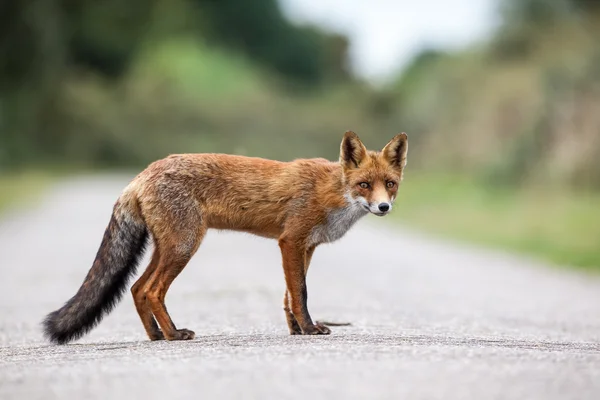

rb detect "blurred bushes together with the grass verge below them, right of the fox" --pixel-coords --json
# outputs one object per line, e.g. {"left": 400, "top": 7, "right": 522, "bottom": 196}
{"left": 384, "top": 0, "right": 600, "bottom": 271}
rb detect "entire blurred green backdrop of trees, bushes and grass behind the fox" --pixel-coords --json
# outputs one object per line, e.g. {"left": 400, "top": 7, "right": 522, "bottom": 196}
{"left": 0, "top": 0, "right": 600, "bottom": 270}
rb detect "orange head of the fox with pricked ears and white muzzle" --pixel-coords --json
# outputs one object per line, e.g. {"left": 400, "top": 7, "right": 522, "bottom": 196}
{"left": 340, "top": 131, "right": 408, "bottom": 216}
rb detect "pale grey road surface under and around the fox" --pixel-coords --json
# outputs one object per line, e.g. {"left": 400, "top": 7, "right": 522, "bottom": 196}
{"left": 0, "top": 176, "right": 600, "bottom": 400}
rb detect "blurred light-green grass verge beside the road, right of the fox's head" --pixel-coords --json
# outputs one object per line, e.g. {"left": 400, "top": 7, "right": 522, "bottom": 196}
{"left": 394, "top": 173, "right": 600, "bottom": 272}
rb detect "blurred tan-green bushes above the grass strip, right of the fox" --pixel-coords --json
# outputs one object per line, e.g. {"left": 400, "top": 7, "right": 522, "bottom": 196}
{"left": 395, "top": 0, "right": 600, "bottom": 188}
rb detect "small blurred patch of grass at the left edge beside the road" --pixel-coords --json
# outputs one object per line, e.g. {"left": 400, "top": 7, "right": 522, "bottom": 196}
{"left": 0, "top": 170, "right": 56, "bottom": 215}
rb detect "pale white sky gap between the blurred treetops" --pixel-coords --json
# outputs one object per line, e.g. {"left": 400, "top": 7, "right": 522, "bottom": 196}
{"left": 279, "top": 0, "right": 497, "bottom": 82}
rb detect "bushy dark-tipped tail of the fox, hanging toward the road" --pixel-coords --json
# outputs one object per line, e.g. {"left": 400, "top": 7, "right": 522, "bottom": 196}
{"left": 43, "top": 202, "right": 148, "bottom": 344}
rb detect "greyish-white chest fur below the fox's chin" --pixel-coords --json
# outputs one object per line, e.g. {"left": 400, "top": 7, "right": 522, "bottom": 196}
{"left": 309, "top": 202, "right": 368, "bottom": 244}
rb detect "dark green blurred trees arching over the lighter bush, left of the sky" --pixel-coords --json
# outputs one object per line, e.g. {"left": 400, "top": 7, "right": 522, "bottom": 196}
{"left": 0, "top": 0, "right": 351, "bottom": 166}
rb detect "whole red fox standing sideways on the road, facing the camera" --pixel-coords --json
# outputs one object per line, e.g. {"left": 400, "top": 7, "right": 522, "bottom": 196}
{"left": 43, "top": 131, "right": 408, "bottom": 344}
